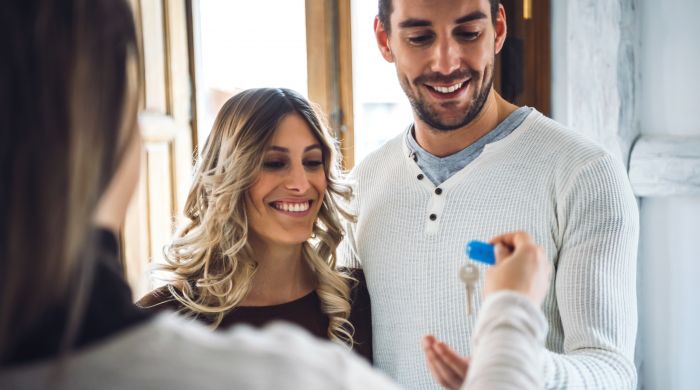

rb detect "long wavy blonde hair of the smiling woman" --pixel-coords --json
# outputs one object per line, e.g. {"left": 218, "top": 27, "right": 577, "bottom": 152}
{"left": 163, "top": 88, "right": 354, "bottom": 345}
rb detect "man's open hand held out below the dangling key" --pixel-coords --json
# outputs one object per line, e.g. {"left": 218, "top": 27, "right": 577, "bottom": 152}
{"left": 423, "top": 336, "right": 469, "bottom": 389}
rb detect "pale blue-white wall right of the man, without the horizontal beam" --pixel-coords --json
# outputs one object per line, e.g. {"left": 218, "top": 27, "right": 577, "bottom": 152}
{"left": 551, "top": 0, "right": 700, "bottom": 390}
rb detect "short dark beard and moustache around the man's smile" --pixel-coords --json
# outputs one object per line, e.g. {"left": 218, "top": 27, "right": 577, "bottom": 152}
{"left": 400, "top": 64, "right": 493, "bottom": 131}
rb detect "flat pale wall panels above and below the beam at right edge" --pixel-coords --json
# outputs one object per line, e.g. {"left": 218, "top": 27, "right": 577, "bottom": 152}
{"left": 638, "top": 0, "right": 700, "bottom": 389}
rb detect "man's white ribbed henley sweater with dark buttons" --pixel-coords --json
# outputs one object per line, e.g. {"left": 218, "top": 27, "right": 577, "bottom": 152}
{"left": 339, "top": 110, "right": 639, "bottom": 389}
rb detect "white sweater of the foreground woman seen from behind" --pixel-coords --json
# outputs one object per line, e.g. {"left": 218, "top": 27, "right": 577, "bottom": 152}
{"left": 0, "top": 292, "right": 547, "bottom": 390}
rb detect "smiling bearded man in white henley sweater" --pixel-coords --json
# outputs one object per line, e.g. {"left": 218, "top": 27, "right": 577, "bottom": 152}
{"left": 341, "top": 0, "right": 639, "bottom": 388}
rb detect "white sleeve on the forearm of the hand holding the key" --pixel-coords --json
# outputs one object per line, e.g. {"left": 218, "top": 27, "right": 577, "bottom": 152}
{"left": 462, "top": 291, "right": 547, "bottom": 390}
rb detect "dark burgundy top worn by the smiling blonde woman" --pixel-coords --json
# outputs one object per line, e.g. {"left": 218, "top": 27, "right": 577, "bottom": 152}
{"left": 136, "top": 270, "right": 372, "bottom": 362}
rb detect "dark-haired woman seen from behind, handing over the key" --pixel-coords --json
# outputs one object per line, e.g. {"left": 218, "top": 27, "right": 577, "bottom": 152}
{"left": 0, "top": 0, "right": 544, "bottom": 389}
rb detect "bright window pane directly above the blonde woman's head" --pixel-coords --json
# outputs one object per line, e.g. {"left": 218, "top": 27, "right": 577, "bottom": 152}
{"left": 193, "top": 0, "right": 308, "bottom": 150}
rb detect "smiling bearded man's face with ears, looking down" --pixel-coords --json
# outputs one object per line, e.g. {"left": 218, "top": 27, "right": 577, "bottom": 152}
{"left": 375, "top": 0, "right": 506, "bottom": 131}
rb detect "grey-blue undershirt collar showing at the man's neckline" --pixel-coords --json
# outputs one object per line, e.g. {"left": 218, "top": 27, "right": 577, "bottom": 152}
{"left": 406, "top": 106, "right": 532, "bottom": 186}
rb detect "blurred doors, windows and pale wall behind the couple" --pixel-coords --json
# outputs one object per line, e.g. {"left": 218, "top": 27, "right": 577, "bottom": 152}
{"left": 121, "top": 0, "right": 700, "bottom": 389}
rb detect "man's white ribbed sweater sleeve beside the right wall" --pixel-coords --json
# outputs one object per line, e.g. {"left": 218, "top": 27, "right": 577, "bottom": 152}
{"left": 545, "top": 154, "right": 639, "bottom": 389}
